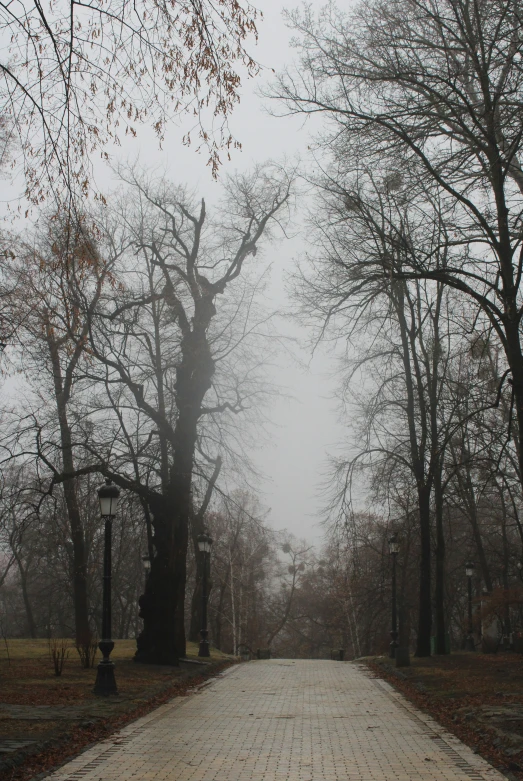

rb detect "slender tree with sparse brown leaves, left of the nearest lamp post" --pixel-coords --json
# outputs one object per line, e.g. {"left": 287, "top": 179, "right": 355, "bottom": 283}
{"left": 2, "top": 216, "right": 107, "bottom": 656}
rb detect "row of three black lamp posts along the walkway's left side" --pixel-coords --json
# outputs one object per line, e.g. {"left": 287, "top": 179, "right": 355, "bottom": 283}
{"left": 93, "top": 479, "right": 212, "bottom": 695}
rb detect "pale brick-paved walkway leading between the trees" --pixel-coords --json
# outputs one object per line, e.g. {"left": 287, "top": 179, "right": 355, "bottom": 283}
{"left": 48, "top": 659, "right": 504, "bottom": 781}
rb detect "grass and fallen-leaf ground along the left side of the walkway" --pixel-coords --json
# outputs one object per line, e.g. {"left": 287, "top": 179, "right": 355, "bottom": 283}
{"left": 0, "top": 640, "right": 234, "bottom": 781}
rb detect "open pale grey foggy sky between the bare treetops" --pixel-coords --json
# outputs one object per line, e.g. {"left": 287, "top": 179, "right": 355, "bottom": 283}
{"left": 9, "top": 0, "right": 343, "bottom": 541}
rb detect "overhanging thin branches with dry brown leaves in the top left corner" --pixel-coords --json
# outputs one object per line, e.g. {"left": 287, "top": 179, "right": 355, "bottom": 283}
{"left": 0, "top": 0, "right": 257, "bottom": 204}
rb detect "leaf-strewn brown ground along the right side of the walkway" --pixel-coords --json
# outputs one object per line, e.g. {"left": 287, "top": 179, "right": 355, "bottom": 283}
{"left": 366, "top": 652, "right": 523, "bottom": 781}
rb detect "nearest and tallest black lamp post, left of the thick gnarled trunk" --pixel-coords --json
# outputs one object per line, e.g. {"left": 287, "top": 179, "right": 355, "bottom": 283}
{"left": 94, "top": 480, "right": 120, "bottom": 695}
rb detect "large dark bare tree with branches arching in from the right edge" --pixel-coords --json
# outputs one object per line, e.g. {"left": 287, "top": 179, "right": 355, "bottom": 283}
{"left": 273, "top": 0, "right": 523, "bottom": 548}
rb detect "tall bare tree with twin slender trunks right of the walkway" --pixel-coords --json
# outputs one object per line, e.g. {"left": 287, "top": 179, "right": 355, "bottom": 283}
{"left": 288, "top": 163, "right": 464, "bottom": 655}
